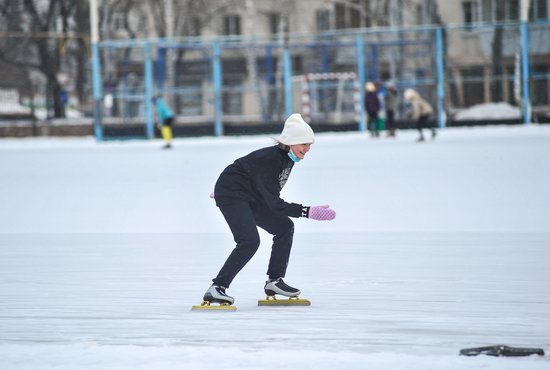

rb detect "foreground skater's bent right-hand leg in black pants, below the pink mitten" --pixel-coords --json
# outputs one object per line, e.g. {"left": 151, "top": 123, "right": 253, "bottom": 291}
{"left": 254, "top": 210, "right": 294, "bottom": 279}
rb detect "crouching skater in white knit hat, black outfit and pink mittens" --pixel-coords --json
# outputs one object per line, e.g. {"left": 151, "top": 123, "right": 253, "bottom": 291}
{"left": 203, "top": 113, "right": 336, "bottom": 304}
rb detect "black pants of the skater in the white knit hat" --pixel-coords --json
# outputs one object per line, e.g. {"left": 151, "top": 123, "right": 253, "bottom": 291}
{"left": 212, "top": 202, "right": 294, "bottom": 288}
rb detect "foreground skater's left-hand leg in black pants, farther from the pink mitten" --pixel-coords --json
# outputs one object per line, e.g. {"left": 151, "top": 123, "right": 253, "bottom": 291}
{"left": 212, "top": 202, "right": 260, "bottom": 288}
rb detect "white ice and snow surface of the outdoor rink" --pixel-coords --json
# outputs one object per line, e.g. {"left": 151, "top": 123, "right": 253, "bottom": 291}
{"left": 0, "top": 125, "right": 550, "bottom": 370}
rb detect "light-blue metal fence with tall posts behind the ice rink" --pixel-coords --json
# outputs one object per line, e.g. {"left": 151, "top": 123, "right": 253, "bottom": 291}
{"left": 4, "top": 22, "right": 550, "bottom": 140}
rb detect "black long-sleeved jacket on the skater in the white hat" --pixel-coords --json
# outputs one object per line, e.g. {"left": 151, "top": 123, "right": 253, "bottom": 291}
{"left": 214, "top": 146, "right": 304, "bottom": 217}
